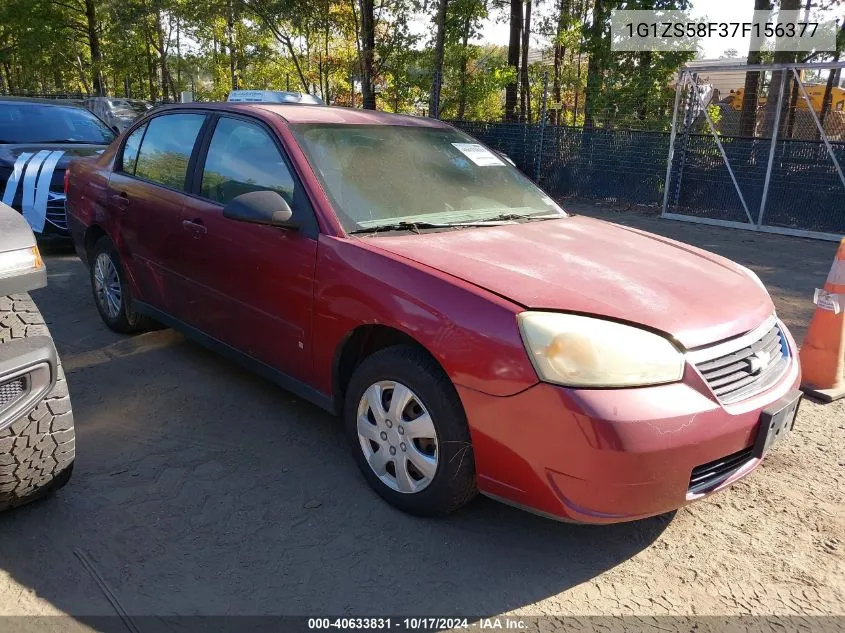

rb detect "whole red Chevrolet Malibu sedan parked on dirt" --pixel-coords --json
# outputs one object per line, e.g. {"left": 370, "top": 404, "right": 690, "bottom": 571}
{"left": 67, "top": 103, "right": 800, "bottom": 523}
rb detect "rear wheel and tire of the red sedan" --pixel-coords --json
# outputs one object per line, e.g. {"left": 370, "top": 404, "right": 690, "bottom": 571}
{"left": 88, "top": 235, "right": 158, "bottom": 334}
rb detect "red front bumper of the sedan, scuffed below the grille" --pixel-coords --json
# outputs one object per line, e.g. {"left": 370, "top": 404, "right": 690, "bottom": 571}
{"left": 458, "top": 320, "right": 800, "bottom": 523}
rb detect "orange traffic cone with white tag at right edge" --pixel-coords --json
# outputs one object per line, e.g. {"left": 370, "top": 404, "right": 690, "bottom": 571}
{"left": 799, "top": 239, "right": 845, "bottom": 402}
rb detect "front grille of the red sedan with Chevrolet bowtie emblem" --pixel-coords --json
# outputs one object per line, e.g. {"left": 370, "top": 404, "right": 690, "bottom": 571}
{"left": 696, "top": 323, "right": 789, "bottom": 404}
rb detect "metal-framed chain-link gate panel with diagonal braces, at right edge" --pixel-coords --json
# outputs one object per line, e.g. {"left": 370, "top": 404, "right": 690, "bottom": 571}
{"left": 663, "top": 64, "right": 845, "bottom": 239}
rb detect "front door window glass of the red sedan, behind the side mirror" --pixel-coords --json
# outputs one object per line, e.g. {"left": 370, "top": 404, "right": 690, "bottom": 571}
{"left": 198, "top": 117, "right": 294, "bottom": 206}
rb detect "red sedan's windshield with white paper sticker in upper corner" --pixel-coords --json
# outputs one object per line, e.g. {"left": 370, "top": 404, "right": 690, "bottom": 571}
{"left": 294, "top": 124, "right": 565, "bottom": 232}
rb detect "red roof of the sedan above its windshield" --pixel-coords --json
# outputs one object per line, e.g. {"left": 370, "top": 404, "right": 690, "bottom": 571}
{"left": 156, "top": 101, "right": 451, "bottom": 128}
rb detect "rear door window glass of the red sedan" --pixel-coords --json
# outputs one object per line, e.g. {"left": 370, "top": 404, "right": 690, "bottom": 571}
{"left": 137, "top": 113, "right": 205, "bottom": 190}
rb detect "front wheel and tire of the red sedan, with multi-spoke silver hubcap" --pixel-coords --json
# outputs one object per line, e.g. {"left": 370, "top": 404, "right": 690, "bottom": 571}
{"left": 344, "top": 345, "right": 477, "bottom": 516}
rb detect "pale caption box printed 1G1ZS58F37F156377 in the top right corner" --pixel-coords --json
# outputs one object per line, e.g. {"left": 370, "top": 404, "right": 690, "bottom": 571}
{"left": 610, "top": 3, "right": 838, "bottom": 54}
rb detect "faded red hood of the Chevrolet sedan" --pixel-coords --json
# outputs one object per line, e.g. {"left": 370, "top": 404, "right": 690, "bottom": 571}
{"left": 364, "top": 216, "right": 774, "bottom": 349}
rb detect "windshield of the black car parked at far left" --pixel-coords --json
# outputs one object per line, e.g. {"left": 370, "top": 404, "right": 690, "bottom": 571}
{"left": 0, "top": 102, "right": 114, "bottom": 145}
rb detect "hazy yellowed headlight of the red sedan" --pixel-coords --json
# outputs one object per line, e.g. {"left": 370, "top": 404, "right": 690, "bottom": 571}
{"left": 517, "top": 312, "right": 684, "bottom": 387}
